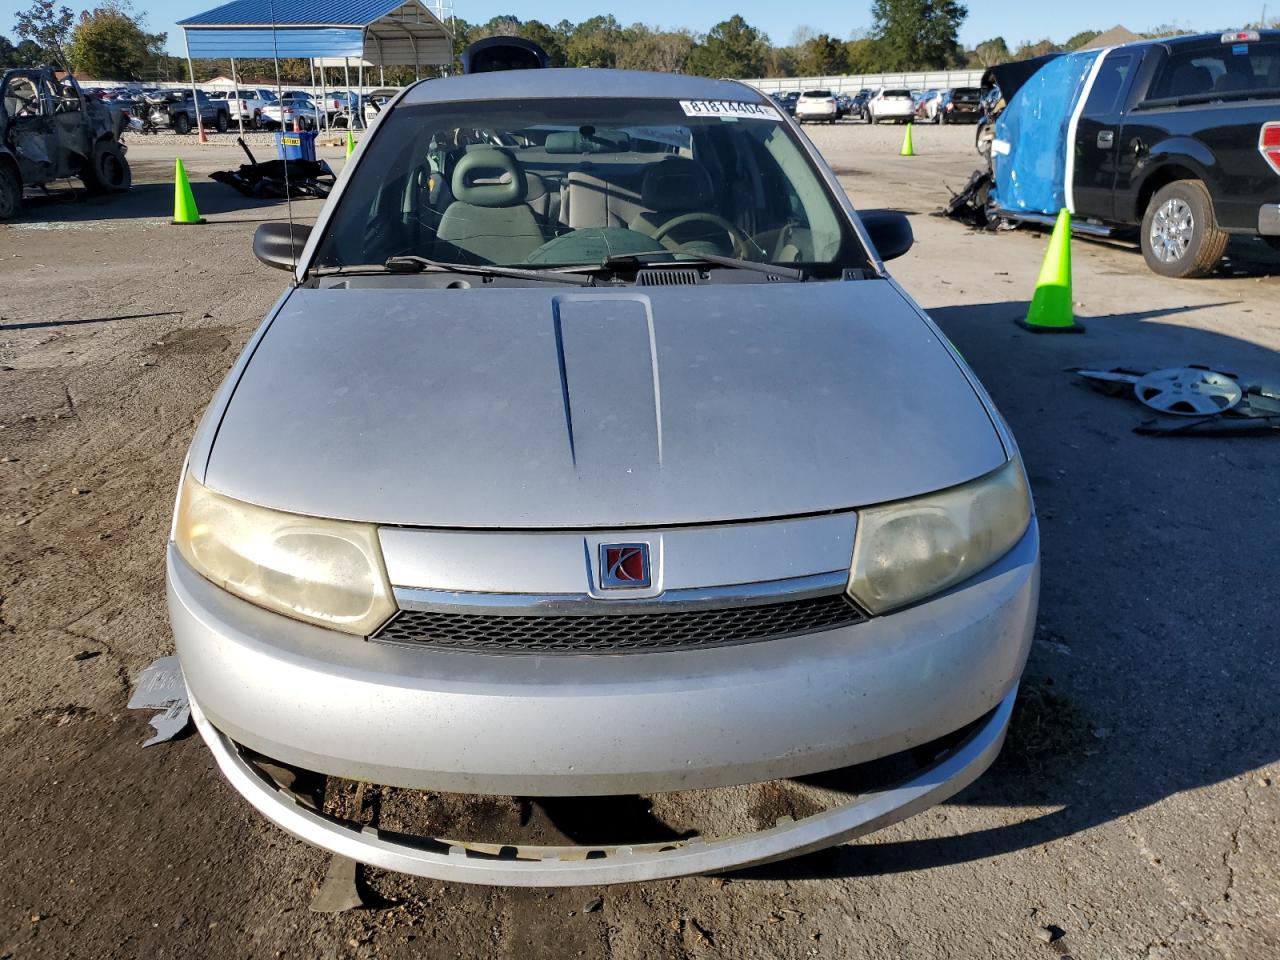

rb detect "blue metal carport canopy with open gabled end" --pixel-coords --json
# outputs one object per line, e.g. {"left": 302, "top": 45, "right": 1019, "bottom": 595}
{"left": 178, "top": 0, "right": 453, "bottom": 67}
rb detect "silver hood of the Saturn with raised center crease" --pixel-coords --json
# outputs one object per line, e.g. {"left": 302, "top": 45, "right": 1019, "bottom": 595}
{"left": 193, "top": 280, "right": 1006, "bottom": 529}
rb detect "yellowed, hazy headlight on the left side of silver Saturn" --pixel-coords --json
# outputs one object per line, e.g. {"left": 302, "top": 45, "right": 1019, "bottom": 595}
{"left": 173, "top": 474, "right": 396, "bottom": 636}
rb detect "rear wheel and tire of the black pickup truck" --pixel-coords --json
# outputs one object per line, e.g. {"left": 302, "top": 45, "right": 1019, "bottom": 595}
{"left": 1139, "top": 180, "right": 1230, "bottom": 278}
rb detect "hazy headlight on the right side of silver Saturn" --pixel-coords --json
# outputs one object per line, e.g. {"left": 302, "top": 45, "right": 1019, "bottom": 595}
{"left": 849, "top": 460, "right": 1032, "bottom": 613}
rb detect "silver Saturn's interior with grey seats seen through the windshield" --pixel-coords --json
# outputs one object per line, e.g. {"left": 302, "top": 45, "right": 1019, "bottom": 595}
{"left": 321, "top": 108, "right": 845, "bottom": 273}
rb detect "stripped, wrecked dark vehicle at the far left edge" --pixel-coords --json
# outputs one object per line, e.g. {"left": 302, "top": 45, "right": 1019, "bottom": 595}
{"left": 0, "top": 69, "right": 132, "bottom": 220}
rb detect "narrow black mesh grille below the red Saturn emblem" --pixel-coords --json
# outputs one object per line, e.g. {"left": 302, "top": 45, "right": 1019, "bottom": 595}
{"left": 374, "top": 594, "right": 865, "bottom": 653}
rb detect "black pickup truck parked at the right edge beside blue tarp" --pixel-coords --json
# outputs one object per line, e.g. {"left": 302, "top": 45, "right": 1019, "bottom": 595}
{"left": 983, "top": 31, "right": 1280, "bottom": 276}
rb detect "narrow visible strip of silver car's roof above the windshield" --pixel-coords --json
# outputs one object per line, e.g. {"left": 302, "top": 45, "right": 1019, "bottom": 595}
{"left": 402, "top": 67, "right": 767, "bottom": 105}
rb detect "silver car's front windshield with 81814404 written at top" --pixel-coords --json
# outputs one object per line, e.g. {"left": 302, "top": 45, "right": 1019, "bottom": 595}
{"left": 315, "top": 97, "right": 868, "bottom": 278}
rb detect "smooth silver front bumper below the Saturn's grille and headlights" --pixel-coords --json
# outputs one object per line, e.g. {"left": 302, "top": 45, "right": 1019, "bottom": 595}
{"left": 168, "top": 525, "right": 1039, "bottom": 796}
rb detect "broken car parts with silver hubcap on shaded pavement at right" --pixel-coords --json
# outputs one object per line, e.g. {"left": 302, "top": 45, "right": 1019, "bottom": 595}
{"left": 1071, "top": 364, "right": 1280, "bottom": 436}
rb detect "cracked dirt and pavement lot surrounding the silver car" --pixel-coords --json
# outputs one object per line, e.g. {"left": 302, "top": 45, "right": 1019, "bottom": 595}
{"left": 0, "top": 125, "right": 1280, "bottom": 960}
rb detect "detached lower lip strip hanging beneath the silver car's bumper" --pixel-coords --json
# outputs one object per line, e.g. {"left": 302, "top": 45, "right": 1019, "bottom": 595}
{"left": 191, "top": 690, "right": 1016, "bottom": 887}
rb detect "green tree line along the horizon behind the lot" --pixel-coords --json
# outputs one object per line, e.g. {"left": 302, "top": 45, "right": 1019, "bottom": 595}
{"left": 0, "top": 0, "right": 1259, "bottom": 86}
